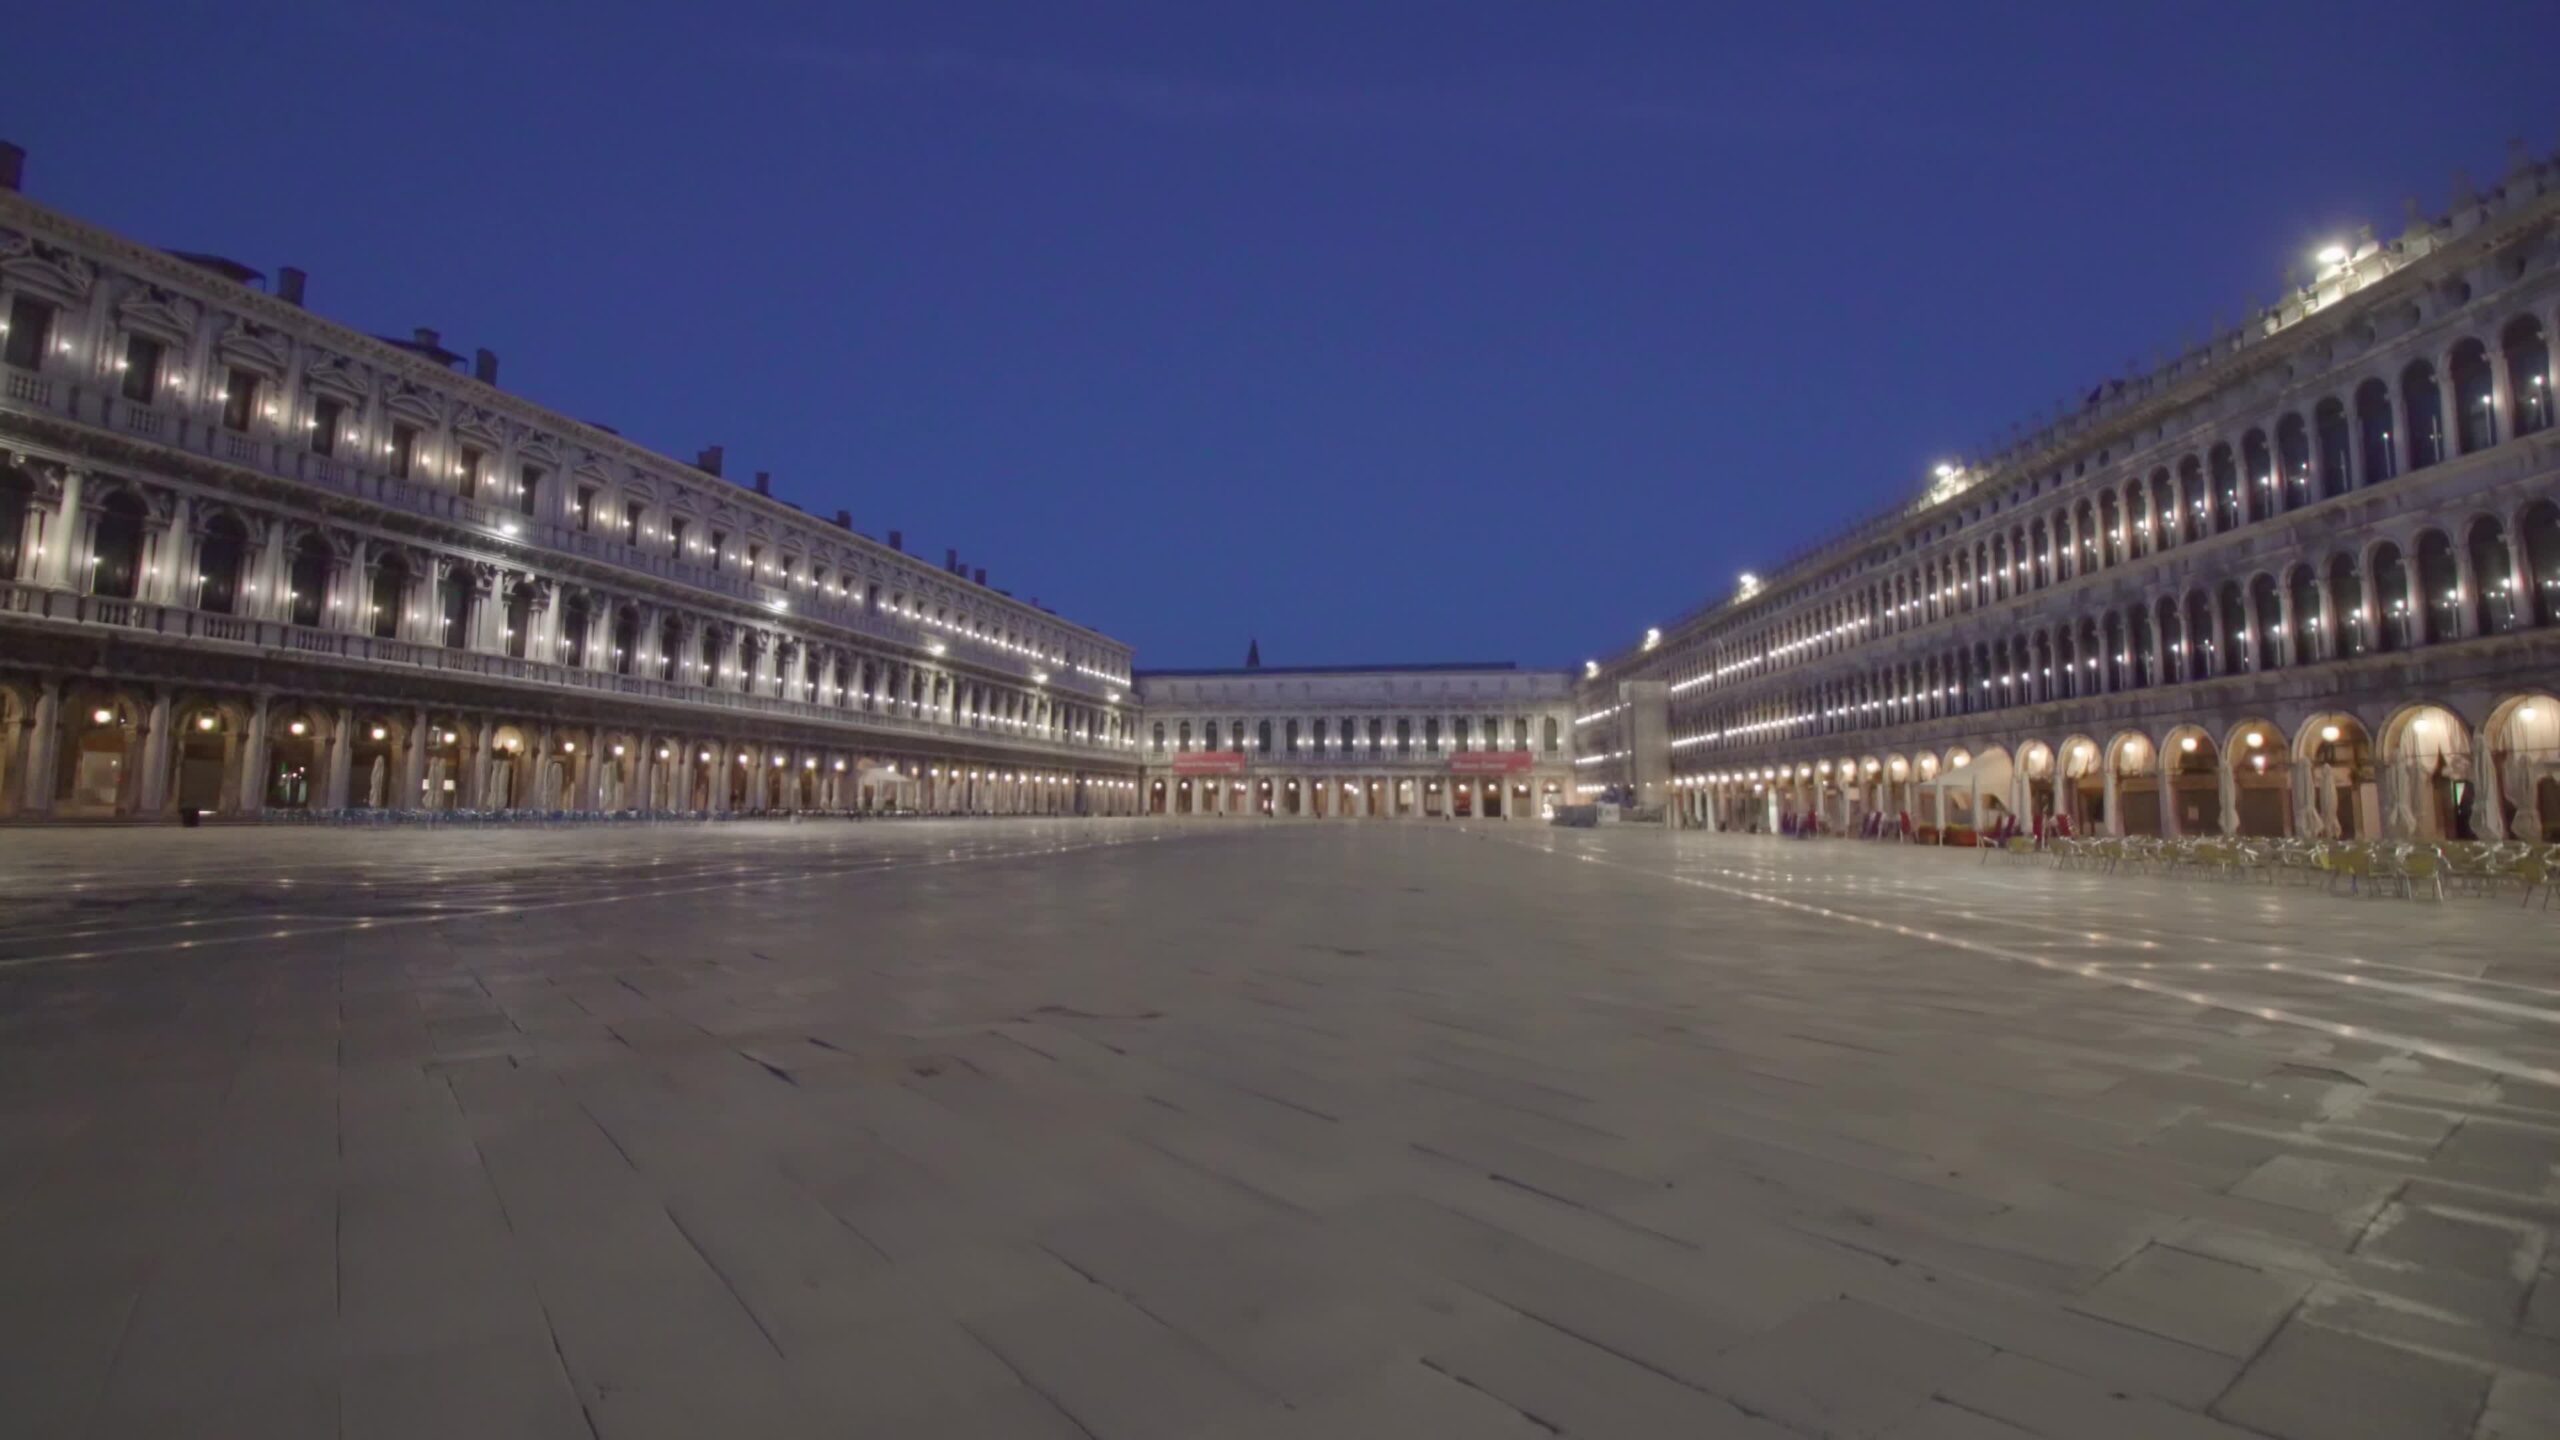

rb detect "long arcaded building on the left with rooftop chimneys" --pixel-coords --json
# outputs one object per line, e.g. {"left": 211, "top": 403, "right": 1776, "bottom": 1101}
{"left": 0, "top": 156, "right": 1139, "bottom": 817}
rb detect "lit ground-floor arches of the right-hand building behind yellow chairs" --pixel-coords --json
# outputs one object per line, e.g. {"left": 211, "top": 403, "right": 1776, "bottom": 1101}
{"left": 1672, "top": 687, "right": 2560, "bottom": 840}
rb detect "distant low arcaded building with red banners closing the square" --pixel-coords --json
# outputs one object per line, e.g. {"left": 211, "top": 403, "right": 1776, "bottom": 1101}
{"left": 1137, "top": 664, "right": 1574, "bottom": 822}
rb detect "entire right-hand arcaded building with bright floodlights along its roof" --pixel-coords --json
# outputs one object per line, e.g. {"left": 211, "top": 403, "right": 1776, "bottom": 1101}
{"left": 1577, "top": 142, "right": 2560, "bottom": 840}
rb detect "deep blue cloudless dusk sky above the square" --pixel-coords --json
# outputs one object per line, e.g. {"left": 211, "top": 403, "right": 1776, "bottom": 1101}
{"left": 0, "top": 0, "right": 2560, "bottom": 666}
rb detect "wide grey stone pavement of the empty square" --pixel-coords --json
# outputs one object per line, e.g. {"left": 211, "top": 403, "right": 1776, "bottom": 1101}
{"left": 0, "top": 820, "right": 2560, "bottom": 1440}
